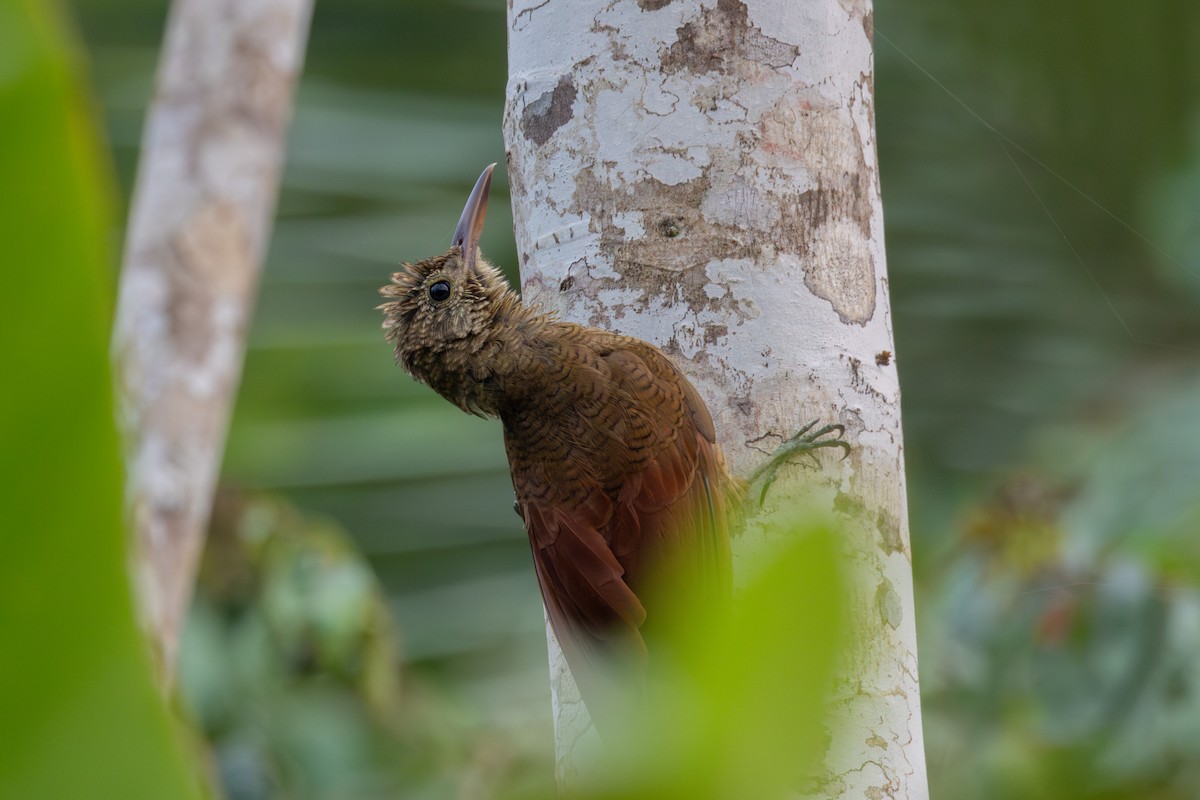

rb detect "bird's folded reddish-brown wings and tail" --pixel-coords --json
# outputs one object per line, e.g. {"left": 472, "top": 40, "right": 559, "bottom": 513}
{"left": 510, "top": 336, "right": 733, "bottom": 698}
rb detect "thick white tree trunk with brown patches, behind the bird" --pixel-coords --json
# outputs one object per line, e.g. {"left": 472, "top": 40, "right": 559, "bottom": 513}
{"left": 505, "top": 0, "right": 928, "bottom": 798}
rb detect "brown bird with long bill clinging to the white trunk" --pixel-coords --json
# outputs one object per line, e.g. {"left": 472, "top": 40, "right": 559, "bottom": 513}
{"left": 378, "top": 164, "right": 848, "bottom": 721}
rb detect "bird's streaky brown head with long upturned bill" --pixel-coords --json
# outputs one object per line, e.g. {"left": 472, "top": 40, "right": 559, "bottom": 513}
{"left": 379, "top": 164, "right": 515, "bottom": 383}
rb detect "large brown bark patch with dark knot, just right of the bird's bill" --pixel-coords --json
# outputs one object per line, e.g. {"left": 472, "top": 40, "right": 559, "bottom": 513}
{"left": 570, "top": 169, "right": 762, "bottom": 335}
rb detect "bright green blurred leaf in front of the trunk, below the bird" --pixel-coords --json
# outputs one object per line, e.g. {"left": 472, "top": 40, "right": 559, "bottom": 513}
{"left": 578, "top": 527, "right": 852, "bottom": 800}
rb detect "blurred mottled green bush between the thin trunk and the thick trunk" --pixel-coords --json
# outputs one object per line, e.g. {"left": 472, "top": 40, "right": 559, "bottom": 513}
{"left": 180, "top": 491, "right": 553, "bottom": 800}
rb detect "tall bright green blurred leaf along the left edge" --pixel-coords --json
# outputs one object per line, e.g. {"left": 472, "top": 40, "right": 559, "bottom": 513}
{"left": 0, "top": 0, "right": 200, "bottom": 800}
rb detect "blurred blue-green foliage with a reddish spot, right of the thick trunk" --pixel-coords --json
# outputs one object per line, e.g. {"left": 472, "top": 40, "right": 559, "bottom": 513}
{"left": 922, "top": 371, "right": 1200, "bottom": 800}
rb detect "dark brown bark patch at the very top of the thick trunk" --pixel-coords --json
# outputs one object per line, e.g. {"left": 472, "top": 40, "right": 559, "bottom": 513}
{"left": 662, "top": 0, "right": 800, "bottom": 74}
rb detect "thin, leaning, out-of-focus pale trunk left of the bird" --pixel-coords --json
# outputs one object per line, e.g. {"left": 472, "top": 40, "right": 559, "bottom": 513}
{"left": 113, "top": 0, "right": 311, "bottom": 685}
